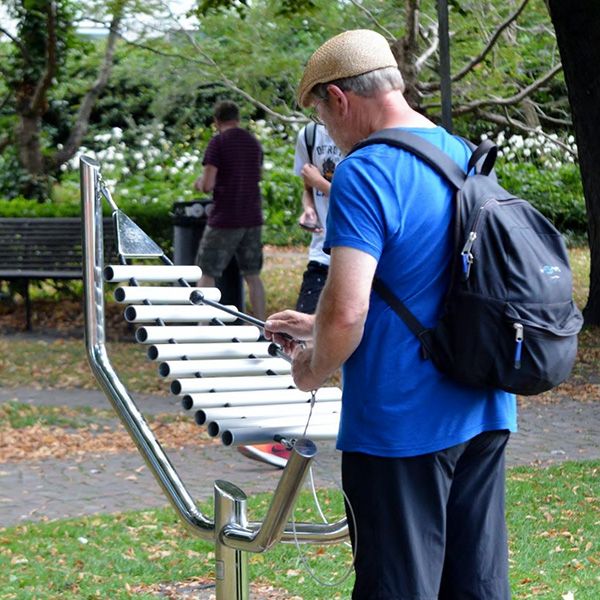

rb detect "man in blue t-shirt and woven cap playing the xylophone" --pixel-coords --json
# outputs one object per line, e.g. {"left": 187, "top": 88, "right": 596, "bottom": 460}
{"left": 266, "top": 30, "right": 516, "bottom": 600}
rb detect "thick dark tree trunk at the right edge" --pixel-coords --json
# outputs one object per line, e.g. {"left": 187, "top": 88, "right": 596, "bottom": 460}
{"left": 547, "top": 0, "right": 600, "bottom": 325}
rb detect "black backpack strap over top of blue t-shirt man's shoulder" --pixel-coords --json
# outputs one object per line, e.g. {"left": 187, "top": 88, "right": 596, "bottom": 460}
{"left": 349, "top": 128, "right": 466, "bottom": 189}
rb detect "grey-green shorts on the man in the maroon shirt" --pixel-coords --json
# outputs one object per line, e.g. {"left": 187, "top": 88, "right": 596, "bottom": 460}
{"left": 196, "top": 225, "right": 263, "bottom": 279}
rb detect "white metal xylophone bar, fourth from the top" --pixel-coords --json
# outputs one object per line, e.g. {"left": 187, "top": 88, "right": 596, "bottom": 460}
{"left": 135, "top": 325, "right": 261, "bottom": 344}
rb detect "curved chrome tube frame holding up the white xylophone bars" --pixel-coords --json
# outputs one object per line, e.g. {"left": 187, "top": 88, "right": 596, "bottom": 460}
{"left": 80, "top": 157, "right": 348, "bottom": 552}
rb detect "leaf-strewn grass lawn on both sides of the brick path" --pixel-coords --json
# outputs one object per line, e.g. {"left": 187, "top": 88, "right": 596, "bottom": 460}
{"left": 0, "top": 249, "right": 600, "bottom": 600}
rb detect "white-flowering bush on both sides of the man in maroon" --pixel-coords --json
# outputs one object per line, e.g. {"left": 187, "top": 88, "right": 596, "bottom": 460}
{"left": 52, "top": 120, "right": 309, "bottom": 246}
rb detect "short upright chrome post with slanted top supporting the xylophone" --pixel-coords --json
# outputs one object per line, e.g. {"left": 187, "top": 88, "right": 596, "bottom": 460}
{"left": 214, "top": 480, "right": 250, "bottom": 600}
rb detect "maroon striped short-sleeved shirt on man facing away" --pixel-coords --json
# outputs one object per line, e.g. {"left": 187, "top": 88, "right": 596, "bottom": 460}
{"left": 202, "top": 127, "right": 263, "bottom": 229}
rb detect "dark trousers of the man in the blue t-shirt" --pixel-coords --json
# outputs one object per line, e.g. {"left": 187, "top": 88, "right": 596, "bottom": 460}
{"left": 342, "top": 431, "right": 510, "bottom": 600}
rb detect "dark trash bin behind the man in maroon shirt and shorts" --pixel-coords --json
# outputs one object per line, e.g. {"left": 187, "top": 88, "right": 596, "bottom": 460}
{"left": 172, "top": 199, "right": 245, "bottom": 311}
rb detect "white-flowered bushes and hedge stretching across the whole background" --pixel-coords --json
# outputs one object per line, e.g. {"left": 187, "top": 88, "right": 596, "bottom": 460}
{"left": 0, "top": 122, "right": 587, "bottom": 252}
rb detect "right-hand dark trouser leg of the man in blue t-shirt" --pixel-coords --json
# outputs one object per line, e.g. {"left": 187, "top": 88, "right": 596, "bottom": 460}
{"left": 439, "top": 431, "right": 510, "bottom": 600}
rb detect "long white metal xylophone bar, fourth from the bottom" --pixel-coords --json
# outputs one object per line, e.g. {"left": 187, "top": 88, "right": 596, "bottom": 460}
{"left": 183, "top": 386, "right": 342, "bottom": 410}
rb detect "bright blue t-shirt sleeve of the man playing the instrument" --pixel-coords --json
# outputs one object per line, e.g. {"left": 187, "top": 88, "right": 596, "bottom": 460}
{"left": 323, "top": 157, "right": 387, "bottom": 260}
